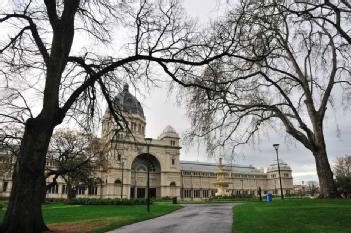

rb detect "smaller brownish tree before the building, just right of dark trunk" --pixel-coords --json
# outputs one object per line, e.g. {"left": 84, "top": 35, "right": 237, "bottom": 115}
{"left": 46, "top": 129, "right": 107, "bottom": 199}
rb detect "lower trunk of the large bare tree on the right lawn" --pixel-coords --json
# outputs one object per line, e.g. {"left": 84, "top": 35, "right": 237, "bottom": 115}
{"left": 314, "top": 148, "right": 337, "bottom": 198}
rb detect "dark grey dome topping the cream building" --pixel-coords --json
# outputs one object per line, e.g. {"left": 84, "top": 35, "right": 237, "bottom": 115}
{"left": 113, "top": 83, "right": 145, "bottom": 118}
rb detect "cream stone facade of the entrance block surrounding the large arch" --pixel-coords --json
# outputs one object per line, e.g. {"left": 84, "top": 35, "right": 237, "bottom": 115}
{"left": 102, "top": 122, "right": 180, "bottom": 197}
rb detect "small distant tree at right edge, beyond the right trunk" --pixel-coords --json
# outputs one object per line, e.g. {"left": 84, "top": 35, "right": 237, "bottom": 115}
{"left": 334, "top": 155, "right": 351, "bottom": 194}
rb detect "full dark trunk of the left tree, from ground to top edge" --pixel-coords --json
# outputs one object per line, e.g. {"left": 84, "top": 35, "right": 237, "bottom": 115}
{"left": 0, "top": 0, "right": 80, "bottom": 233}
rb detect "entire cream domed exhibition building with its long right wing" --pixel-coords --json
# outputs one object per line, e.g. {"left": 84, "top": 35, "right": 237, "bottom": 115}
{"left": 0, "top": 84, "right": 293, "bottom": 199}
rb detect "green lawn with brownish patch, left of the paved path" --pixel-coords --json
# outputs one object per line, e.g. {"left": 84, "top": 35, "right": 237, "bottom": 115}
{"left": 0, "top": 203, "right": 181, "bottom": 233}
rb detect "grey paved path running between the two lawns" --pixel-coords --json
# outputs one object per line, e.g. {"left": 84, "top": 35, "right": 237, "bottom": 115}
{"left": 108, "top": 203, "right": 236, "bottom": 233}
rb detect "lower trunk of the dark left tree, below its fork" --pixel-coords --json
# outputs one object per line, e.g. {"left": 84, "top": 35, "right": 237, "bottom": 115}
{"left": 0, "top": 117, "right": 54, "bottom": 233}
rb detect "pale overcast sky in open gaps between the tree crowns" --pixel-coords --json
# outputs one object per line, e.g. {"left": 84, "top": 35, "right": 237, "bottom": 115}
{"left": 141, "top": 0, "right": 351, "bottom": 184}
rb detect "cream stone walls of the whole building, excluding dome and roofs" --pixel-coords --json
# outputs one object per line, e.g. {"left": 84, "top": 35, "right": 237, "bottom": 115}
{"left": 0, "top": 108, "right": 293, "bottom": 198}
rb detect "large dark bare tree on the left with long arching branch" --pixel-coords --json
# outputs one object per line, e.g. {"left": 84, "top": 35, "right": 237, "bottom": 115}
{"left": 0, "top": 0, "right": 231, "bottom": 233}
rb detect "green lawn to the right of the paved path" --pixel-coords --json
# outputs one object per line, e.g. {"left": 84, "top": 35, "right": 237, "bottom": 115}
{"left": 233, "top": 199, "right": 351, "bottom": 233}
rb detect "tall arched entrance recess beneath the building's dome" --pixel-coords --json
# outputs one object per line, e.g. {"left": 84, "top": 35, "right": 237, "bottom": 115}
{"left": 130, "top": 154, "right": 161, "bottom": 198}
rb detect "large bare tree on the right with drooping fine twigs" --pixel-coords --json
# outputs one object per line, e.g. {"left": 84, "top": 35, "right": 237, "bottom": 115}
{"left": 171, "top": 1, "right": 350, "bottom": 197}
